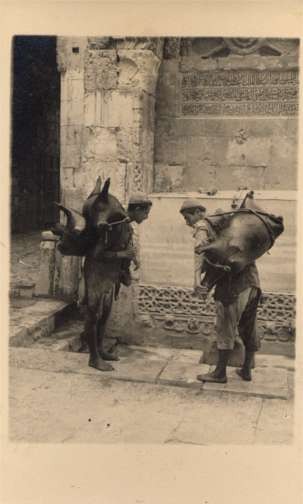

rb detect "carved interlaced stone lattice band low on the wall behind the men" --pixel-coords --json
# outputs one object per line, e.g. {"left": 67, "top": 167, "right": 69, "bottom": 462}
{"left": 136, "top": 285, "right": 296, "bottom": 342}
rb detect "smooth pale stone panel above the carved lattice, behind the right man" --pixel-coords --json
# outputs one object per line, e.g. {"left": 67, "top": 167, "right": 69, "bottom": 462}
{"left": 140, "top": 192, "right": 296, "bottom": 294}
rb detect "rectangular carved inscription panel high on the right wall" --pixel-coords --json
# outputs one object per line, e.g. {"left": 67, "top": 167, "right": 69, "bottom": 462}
{"left": 181, "top": 69, "right": 299, "bottom": 116}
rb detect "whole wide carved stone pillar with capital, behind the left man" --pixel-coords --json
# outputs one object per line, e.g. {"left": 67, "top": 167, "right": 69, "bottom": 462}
{"left": 81, "top": 38, "right": 163, "bottom": 341}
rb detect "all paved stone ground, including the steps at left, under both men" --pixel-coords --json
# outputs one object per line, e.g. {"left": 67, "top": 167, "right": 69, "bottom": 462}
{"left": 9, "top": 233, "right": 294, "bottom": 445}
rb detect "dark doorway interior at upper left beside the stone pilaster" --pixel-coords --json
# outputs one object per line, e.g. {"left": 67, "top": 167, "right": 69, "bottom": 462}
{"left": 11, "top": 36, "right": 60, "bottom": 233}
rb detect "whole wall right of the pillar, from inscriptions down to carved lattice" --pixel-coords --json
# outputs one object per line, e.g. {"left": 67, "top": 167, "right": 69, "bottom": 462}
{"left": 137, "top": 38, "right": 299, "bottom": 347}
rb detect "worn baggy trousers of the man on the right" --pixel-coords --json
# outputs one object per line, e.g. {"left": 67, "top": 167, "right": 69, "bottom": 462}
{"left": 216, "top": 287, "right": 260, "bottom": 352}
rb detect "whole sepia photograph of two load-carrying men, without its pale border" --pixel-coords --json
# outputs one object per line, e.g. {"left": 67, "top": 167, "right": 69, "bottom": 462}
{"left": 8, "top": 32, "right": 300, "bottom": 444}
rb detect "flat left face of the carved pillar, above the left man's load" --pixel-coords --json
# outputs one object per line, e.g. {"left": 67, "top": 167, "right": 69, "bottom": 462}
{"left": 79, "top": 42, "right": 128, "bottom": 201}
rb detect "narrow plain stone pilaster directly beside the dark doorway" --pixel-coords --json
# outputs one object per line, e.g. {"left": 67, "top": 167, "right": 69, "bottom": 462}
{"left": 56, "top": 37, "right": 87, "bottom": 299}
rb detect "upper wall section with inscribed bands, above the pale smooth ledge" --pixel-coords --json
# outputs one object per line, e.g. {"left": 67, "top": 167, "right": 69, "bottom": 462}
{"left": 154, "top": 38, "right": 299, "bottom": 192}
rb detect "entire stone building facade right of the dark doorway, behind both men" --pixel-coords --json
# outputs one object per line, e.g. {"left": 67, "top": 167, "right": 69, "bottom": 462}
{"left": 56, "top": 37, "right": 299, "bottom": 348}
